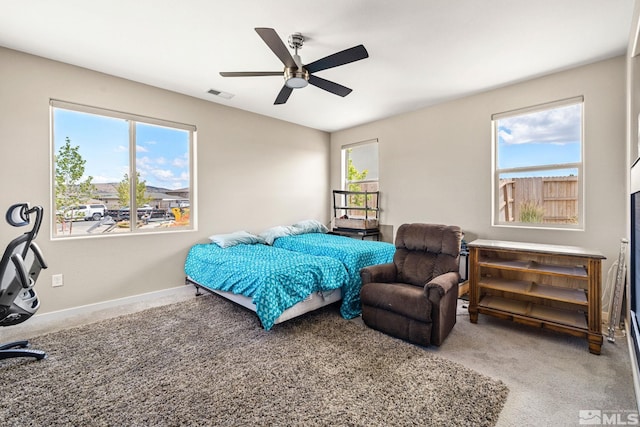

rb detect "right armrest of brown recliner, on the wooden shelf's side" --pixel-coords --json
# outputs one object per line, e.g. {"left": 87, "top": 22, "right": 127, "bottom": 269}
{"left": 424, "top": 272, "right": 460, "bottom": 345}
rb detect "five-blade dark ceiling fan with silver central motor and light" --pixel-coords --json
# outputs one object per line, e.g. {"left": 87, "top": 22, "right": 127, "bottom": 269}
{"left": 220, "top": 28, "right": 369, "bottom": 104}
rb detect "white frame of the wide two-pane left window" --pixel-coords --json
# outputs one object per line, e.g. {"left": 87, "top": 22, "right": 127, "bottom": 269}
{"left": 49, "top": 99, "right": 197, "bottom": 240}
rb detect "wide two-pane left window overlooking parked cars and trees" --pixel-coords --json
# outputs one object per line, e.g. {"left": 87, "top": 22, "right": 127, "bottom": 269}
{"left": 51, "top": 101, "right": 195, "bottom": 238}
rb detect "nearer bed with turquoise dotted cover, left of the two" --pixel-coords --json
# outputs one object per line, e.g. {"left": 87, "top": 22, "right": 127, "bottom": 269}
{"left": 185, "top": 242, "right": 348, "bottom": 330}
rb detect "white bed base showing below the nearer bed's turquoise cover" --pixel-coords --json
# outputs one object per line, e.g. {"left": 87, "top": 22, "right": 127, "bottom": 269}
{"left": 185, "top": 276, "right": 342, "bottom": 325}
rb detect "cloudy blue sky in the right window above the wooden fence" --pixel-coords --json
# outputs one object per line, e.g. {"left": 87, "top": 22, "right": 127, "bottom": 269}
{"left": 497, "top": 104, "right": 582, "bottom": 176}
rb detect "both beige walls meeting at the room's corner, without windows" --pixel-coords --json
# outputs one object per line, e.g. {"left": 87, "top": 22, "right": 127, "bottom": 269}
{"left": 0, "top": 48, "right": 627, "bottom": 313}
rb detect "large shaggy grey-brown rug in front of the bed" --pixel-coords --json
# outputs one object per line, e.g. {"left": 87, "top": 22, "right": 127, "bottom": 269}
{"left": 0, "top": 296, "right": 508, "bottom": 426}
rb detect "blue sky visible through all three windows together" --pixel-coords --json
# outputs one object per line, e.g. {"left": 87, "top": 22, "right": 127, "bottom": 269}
{"left": 54, "top": 103, "right": 582, "bottom": 189}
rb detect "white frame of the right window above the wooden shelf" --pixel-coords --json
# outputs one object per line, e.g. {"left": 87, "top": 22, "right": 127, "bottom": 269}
{"left": 491, "top": 96, "right": 586, "bottom": 231}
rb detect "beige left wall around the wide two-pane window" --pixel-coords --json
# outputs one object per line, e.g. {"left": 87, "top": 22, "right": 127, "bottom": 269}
{"left": 0, "top": 48, "right": 329, "bottom": 313}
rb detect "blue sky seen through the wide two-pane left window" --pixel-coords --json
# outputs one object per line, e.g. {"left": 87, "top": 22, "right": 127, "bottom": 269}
{"left": 53, "top": 108, "right": 189, "bottom": 189}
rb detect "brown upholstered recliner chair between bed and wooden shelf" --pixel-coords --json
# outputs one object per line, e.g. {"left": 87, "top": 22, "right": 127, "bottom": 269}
{"left": 360, "top": 224, "right": 462, "bottom": 346}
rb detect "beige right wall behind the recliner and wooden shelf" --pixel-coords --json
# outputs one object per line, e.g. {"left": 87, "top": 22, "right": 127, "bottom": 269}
{"left": 331, "top": 57, "right": 627, "bottom": 273}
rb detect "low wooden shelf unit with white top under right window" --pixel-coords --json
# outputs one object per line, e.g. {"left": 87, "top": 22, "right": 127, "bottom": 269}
{"left": 468, "top": 240, "right": 605, "bottom": 354}
